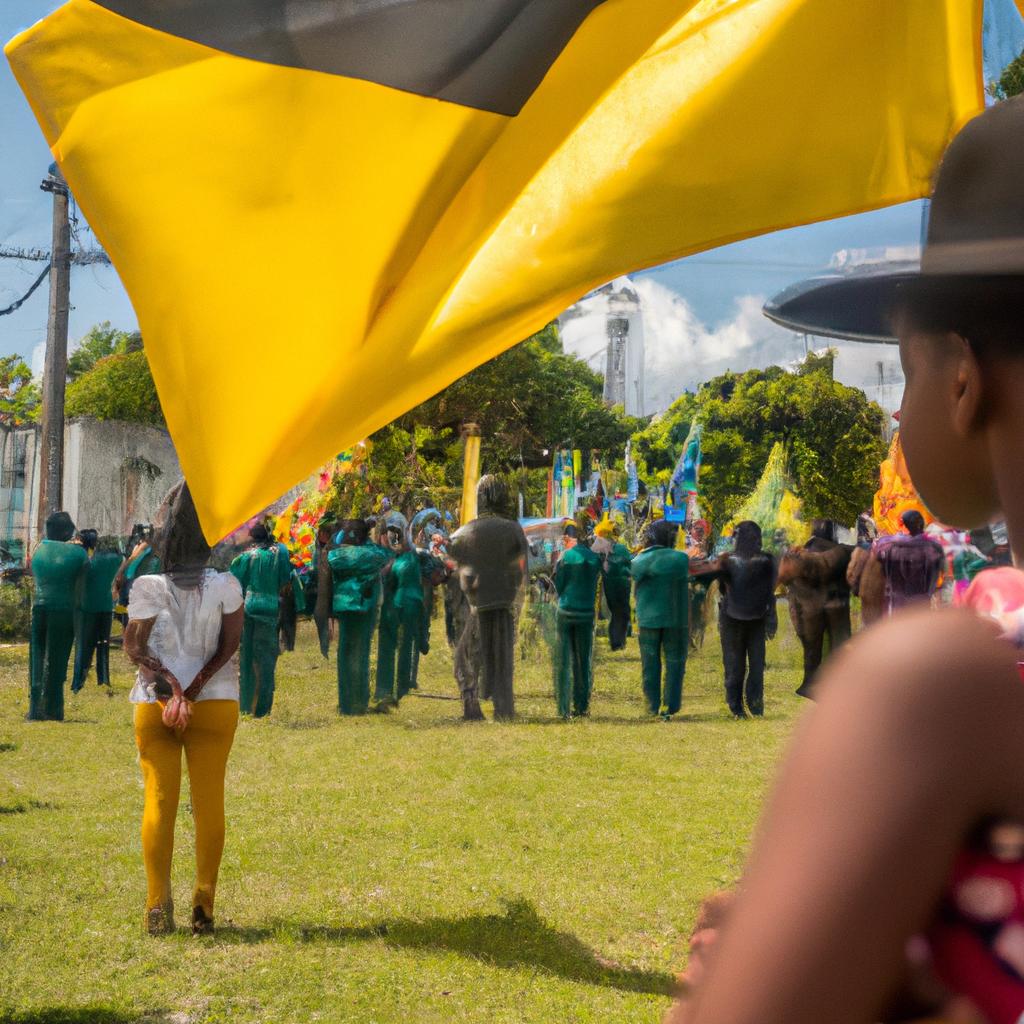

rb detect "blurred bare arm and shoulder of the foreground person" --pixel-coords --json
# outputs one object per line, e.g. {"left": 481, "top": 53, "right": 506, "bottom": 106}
{"left": 674, "top": 611, "right": 1024, "bottom": 1024}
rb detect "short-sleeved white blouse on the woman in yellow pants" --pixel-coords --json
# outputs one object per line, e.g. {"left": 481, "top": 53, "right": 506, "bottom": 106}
{"left": 128, "top": 569, "right": 242, "bottom": 703}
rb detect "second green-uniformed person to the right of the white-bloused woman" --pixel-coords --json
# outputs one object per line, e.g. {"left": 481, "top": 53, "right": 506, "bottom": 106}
{"left": 327, "top": 519, "right": 390, "bottom": 715}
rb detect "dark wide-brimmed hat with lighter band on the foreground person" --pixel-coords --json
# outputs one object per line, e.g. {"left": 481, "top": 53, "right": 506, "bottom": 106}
{"left": 764, "top": 95, "right": 1024, "bottom": 344}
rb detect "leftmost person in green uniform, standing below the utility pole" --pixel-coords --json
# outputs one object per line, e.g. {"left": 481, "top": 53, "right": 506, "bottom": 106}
{"left": 29, "top": 512, "right": 89, "bottom": 722}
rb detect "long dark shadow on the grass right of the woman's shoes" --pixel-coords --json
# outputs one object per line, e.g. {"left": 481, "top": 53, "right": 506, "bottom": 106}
{"left": 216, "top": 899, "right": 675, "bottom": 995}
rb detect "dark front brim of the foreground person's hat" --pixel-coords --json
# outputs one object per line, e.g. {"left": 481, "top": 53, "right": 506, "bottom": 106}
{"left": 762, "top": 260, "right": 922, "bottom": 345}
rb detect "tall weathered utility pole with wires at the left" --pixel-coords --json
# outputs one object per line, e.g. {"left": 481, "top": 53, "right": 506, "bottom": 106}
{"left": 37, "top": 164, "right": 71, "bottom": 538}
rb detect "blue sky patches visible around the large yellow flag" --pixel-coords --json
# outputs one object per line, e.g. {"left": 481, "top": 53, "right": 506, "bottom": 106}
{"left": 6, "top": 0, "right": 1024, "bottom": 369}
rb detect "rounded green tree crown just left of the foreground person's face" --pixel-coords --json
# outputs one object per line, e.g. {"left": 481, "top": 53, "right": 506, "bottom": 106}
{"left": 634, "top": 353, "right": 886, "bottom": 527}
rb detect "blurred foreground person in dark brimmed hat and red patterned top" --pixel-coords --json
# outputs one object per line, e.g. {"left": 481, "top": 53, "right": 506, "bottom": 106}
{"left": 670, "top": 96, "right": 1024, "bottom": 1024}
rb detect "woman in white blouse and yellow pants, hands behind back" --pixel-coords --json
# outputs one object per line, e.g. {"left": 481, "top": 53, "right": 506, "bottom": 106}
{"left": 124, "top": 481, "right": 243, "bottom": 935}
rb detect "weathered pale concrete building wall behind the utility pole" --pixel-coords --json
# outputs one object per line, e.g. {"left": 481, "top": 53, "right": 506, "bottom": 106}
{"left": 0, "top": 416, "right": 181, "bottom": 557}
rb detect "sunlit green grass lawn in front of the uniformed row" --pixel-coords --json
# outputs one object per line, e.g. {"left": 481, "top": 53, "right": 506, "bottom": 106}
{"left": 0, "top": 605, "right": 801, "bottom": 1024}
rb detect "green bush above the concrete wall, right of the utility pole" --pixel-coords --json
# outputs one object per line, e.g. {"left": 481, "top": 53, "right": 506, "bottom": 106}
{"left": 66, "top": 349, "right": 166, "bottom": 427}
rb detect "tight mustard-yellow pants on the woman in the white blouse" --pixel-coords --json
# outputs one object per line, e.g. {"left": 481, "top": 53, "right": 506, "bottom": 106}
{"left": 135, "top": 700, "right": 239, "bottom": 918}
